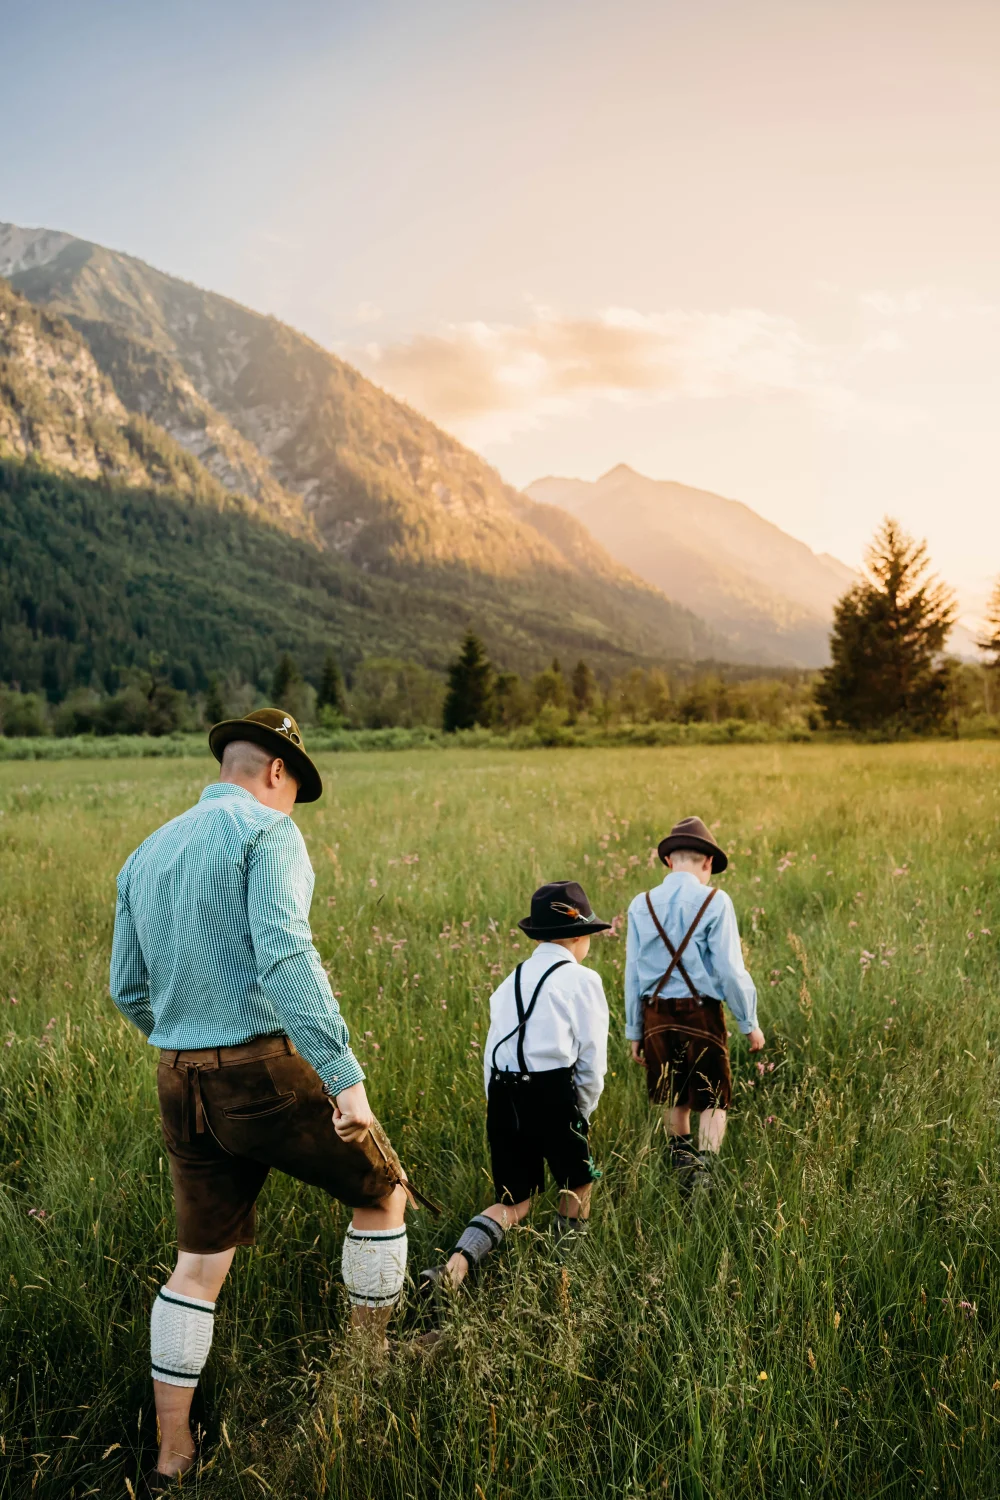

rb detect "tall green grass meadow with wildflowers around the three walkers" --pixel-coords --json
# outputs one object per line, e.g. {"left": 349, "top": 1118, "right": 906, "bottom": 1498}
{"left": 0, "top": 744, "right": 1000, "bottom": 1500}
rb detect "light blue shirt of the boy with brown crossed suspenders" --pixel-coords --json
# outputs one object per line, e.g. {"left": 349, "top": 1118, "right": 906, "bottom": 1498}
{"left": 625, "top": 870, "right": 757, "bottom": 1041}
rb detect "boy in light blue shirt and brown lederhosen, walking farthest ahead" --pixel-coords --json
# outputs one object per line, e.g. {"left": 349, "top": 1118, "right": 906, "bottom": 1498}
{"left": 625, "top": 818, "right": 765, "bottom": 1193}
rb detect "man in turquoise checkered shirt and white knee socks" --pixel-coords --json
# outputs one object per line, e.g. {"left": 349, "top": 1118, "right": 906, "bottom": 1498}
{"left": 111, "top": 708, "right": 408, "bottom": 1494}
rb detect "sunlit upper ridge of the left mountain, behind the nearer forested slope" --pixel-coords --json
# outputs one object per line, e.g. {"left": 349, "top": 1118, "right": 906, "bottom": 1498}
{"left": 0, "top": 225, "right": 722, "bottom": 665}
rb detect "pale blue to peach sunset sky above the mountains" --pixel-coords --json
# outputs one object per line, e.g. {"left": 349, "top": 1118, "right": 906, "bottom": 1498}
{"left": 0, "top": 0, "right": 1000, "bottom": 623}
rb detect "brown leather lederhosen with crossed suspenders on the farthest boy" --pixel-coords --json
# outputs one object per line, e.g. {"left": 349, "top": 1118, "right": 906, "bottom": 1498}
{"left": 643, "top": 890, "right": 733, "bottom": 1110}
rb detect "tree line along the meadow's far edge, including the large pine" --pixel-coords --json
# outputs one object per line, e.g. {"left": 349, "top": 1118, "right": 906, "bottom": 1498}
{"left": 0, "top": 519, "right": 1000, "bottom": 735}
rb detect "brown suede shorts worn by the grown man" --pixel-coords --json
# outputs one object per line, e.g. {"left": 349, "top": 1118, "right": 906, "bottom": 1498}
{"left": 156, "top": 1037, "right": 394, "bottom": 1256}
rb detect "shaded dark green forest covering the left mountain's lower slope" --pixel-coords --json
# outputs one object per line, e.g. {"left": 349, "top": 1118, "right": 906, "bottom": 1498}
{"left": 0, "top": 461, "right": 719, "bottom": 701}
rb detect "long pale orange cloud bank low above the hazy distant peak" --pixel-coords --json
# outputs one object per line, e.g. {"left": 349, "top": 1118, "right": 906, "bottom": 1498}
{"left": 360, "top": 308, "right": 899, "bottom": 443}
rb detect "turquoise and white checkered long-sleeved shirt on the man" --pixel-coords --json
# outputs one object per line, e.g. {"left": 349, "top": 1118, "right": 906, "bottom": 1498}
{"left": 111, "top": 782, "right": 364, "bottom": 1094}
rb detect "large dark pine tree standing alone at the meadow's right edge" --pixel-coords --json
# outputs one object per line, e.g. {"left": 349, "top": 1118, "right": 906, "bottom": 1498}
{"left": 816, "top": 519, "right": 955, "bottom": 734}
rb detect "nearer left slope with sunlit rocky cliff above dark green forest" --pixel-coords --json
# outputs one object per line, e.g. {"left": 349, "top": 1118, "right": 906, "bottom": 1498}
{"left": 0, "top": 273, "right": 722, "bottom": 699}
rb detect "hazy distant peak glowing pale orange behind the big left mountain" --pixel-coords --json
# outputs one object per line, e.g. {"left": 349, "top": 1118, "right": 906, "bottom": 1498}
{"left": 526, "top": 464, "right": 856, "bottom": 666}
